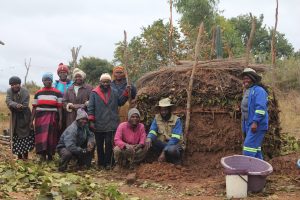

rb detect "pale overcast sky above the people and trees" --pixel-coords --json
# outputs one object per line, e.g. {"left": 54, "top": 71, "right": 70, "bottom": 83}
{"left": 0, "top": 0, "right": 300, "bottom": 91}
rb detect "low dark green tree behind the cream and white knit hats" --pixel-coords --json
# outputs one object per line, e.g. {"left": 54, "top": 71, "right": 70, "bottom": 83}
{"left": 78, "top": 56, "right": 113, "bottom": 85}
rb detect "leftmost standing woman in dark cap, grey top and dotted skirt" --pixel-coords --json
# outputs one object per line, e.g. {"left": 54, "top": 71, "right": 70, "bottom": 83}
{"left": 5, "top": 76, "right": 34, "bottom": 159}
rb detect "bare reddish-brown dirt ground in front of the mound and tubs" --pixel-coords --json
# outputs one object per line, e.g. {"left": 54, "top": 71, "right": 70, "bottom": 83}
{"left": 0, "top": 142, "right": 300, "bottom": 200}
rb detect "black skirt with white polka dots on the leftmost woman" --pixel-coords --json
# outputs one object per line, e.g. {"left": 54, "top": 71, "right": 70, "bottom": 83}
{"left": 12, "top": 131, "right": 34, "bottom": 155}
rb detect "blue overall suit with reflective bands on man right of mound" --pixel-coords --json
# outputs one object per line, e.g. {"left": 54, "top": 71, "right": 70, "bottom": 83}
{"left": 242, "top": 85, "right": 269, "bottom": 159}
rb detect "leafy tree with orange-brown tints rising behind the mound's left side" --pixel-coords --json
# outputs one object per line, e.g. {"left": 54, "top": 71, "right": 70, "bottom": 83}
{"left": 114, "top": 19, "right": 182, "bottom": 80}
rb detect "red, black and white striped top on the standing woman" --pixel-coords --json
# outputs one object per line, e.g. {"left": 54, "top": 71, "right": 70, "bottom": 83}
{"left": 32, "top": 87, "right": 62, "bottom": 111}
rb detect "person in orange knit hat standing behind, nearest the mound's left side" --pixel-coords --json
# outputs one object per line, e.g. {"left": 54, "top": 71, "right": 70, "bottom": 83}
{"left": 111, "top": 66, "right": 136, "bottom": 122}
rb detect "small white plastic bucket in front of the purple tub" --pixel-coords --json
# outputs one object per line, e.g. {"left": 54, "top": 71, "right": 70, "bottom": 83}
{"left": 226, "top": 175, "right": 248, "bottom": 199}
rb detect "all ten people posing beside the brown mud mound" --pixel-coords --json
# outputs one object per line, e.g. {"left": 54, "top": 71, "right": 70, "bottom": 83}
{"left": 6, "top": 63, "right": 268, "bottom": 171}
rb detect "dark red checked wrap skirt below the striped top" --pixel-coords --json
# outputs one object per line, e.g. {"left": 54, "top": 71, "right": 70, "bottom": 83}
{"left": 35, "top": 111, "right": 58, "bottom": 155}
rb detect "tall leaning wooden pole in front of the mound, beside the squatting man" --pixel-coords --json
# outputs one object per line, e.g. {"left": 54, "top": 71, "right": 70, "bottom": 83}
{"left": 183, "top": 22, "right": 204, "bottom": 146}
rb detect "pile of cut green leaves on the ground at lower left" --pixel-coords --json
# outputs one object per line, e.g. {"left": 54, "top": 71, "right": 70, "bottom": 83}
{"left": 0, "top": 161, "right": 125, "bottom": 200}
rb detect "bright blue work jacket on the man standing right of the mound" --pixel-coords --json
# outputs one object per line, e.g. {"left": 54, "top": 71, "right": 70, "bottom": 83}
{"left": 242, "top": 85, "right": 269, "bottom": 133}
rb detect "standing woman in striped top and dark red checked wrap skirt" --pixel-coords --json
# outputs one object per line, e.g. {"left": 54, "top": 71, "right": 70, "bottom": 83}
{"left": 31, "top": 73, "right": 62, "bottom": 161}
